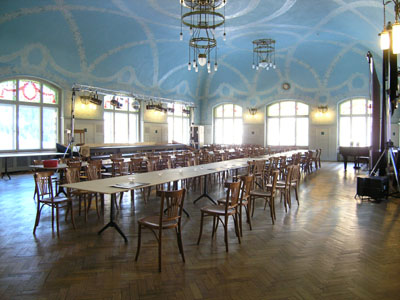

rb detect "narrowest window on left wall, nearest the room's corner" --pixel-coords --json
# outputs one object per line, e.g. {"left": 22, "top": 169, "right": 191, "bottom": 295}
{"left": 167, "top": 103, "right": 190, "bottom": 144}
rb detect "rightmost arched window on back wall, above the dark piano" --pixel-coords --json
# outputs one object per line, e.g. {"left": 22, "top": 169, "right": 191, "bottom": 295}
{"left": 339, "top": 98, "right": 372, "bottom": 147}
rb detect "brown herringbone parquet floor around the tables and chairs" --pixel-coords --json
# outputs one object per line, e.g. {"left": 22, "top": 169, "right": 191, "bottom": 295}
{"left": 0, "top": 163, "right": 400, "bottom": 299}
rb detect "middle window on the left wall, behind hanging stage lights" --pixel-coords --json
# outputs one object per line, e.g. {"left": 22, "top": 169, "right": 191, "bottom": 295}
{"left": 104, "top": 95, "right": 140, "bottom": 143}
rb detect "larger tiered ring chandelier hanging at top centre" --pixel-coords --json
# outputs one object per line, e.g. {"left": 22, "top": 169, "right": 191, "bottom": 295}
{"left": 179, "top": 0, "right": 227, "bottom": 73}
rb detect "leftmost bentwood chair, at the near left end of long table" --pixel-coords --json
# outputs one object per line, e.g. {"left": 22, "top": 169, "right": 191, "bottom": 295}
{"left": 33, "top": 171, "right": 75, "bottom": 237}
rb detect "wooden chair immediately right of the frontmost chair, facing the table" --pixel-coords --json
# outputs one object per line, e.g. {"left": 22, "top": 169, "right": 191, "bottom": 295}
{"left": 197, "top": 181, "right": 241, "bottom": 252}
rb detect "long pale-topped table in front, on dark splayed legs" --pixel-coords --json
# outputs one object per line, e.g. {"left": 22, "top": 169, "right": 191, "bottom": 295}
{"left": 62, "top": 151, "right": 306, "bottom": 242}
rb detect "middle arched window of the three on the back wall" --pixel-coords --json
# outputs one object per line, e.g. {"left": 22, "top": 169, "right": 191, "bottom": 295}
{"left": 267, "top": 101, "right": 309, "bottom": 146}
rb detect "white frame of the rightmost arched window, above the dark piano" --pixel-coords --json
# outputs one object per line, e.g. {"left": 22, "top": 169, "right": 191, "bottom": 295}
{"left": 337, "top": 97, "right": 372, "bottom": 147}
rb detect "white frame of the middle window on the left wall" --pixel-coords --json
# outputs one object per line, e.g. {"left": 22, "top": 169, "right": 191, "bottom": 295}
{"left": 103, "top": 95, "right": 142, "bottom": 144}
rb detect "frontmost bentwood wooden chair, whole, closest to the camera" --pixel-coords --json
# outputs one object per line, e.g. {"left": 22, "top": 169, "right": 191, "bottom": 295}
{"left": 135, "top": 189, "right": 186, "bottom": 272}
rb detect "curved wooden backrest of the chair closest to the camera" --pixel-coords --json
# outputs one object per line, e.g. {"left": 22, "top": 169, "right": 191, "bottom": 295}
{"left": 157, "top": 189, "right": 186, "bottom": 227}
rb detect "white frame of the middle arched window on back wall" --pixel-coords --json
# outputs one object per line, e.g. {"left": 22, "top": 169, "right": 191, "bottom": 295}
{"left": 265, "top": 99, "right": 311, "bottom": 147}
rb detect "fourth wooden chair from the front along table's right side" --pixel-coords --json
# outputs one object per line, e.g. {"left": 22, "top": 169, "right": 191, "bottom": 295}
{"left": 249, "top": 170, "right": 279, "bottom": 224}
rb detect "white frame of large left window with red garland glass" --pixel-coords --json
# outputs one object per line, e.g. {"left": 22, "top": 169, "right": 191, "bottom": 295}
{"left": 0, "top": 76, "right": 62, "bottom": 153}
